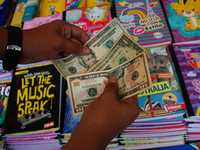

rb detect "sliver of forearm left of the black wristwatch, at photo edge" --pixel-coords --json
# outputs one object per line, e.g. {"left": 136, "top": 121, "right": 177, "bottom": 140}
{"left": 0, "top": 27, "right": 8, "bottom": 60}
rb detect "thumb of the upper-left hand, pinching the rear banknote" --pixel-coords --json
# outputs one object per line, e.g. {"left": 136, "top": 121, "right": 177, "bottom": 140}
{"left": 63, "top": 39, "right": 90, "bottom": 55}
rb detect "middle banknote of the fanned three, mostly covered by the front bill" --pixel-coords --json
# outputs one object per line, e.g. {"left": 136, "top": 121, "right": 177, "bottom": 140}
{"left": 87, "top": 32, "right": 148, "bottom": 72}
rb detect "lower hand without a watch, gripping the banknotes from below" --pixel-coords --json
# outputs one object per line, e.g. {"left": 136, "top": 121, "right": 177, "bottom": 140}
{"left": 63, "top": 77, "right": 139, "bottom": 150}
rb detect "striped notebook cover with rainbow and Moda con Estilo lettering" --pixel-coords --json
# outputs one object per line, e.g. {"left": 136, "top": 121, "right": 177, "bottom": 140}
{"left": 115, "top": 0, "right": 172, "bottom": 47}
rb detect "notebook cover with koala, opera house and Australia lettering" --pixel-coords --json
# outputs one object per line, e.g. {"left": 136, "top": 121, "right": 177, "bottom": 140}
{"left": 137, "top": 46, "right": 186, "bottom": 119}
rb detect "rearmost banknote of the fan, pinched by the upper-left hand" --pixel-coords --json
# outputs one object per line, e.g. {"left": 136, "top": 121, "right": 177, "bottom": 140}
{"left": 52, "top": 18, "right": 131, "bottom": 79}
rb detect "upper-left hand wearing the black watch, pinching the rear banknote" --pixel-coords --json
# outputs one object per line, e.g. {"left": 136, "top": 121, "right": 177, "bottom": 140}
{"left": 19, "top": 20, "right": 90, "bottom": 64}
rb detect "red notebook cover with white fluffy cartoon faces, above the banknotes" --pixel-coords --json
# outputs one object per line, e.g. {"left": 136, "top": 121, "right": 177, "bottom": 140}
{"left": 64, "top": 4, "right": 112, "bottom": 37}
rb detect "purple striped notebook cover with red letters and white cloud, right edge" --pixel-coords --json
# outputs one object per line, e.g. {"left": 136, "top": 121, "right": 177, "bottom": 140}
{"left": 173, "top": 43, "right": 200, "bottom": 116}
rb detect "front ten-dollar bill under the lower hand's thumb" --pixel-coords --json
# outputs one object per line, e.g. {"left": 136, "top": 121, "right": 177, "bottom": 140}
{"left": 67, "top": 52, "right": 152, "bottom": 115}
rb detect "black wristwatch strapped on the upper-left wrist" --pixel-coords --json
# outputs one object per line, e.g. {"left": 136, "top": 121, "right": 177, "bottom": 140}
{"left": 3, "top": 26, "right": 22, "bottom": 71}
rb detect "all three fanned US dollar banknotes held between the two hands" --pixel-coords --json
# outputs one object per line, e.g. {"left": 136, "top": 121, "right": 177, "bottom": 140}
{"left": 52, "top": 18, "right": 152, "bottom": 115}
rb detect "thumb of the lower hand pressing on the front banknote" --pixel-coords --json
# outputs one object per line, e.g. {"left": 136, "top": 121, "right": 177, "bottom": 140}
{"left": 104, "top": 76, "right": 118, "bottom": 96}
